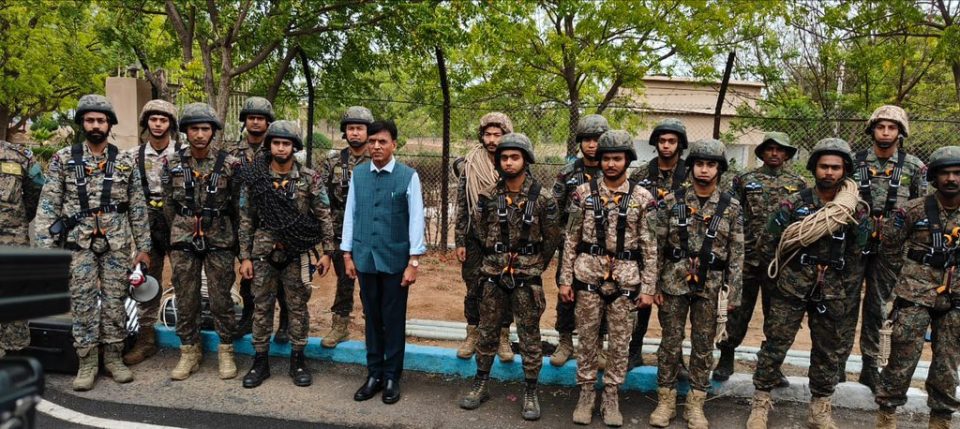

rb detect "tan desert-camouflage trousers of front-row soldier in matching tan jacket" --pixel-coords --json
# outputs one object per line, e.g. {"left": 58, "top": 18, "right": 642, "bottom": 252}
{"left": 576, "top": 290, "right": 637, "bottom": 386}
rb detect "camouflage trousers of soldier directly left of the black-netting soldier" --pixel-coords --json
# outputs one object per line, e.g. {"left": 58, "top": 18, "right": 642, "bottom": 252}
{"left": 170, "top": 250, "right": 237, "bottom": 345}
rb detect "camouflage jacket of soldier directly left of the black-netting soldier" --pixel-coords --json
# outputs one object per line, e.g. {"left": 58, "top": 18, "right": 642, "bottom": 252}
{"left": 163, "top": 147, "right": 240, "bottom": 249}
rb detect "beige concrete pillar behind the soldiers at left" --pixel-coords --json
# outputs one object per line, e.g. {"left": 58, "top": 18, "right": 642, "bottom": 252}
{"left": 106, "top": 77, "right": 151, "bottom": 149}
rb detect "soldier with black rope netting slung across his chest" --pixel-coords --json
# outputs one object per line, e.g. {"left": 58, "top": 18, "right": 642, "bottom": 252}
{"left": 239, "top": 121, "right": 333, "bottom": 388}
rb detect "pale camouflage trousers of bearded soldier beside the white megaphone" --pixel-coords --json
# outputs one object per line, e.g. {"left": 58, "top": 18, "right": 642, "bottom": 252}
{"left": 70, "top": 249, "right": 130, "bottom": 349}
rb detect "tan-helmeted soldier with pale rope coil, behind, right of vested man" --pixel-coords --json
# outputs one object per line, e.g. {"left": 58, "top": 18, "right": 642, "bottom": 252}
{"left": 453, "top": 112, "right": 514, "bottom": 362}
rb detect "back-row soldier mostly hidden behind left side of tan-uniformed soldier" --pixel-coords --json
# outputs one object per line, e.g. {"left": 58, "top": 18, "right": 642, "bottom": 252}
{"left": 550, "top": 115, "right": 610, "bottom": 366}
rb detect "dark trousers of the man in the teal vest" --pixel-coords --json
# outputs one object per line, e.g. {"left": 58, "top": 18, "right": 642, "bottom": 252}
{"left": 357, "top": 273, "right": 410, "bottom": 380}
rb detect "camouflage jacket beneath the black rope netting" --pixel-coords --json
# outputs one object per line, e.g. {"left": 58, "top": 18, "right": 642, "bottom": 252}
{"left": 238, "top": 163, "right": 334, "bottom": 260}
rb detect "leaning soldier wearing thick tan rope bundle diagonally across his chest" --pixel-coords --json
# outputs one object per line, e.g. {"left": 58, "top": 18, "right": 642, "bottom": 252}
{"left": 747, "top": 138, "right": 871, "bottom": 429}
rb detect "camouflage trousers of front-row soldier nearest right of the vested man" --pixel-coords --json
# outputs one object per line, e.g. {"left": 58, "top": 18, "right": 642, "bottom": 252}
{"left": 477, "top": 279, "right": 546, "bottom": 380}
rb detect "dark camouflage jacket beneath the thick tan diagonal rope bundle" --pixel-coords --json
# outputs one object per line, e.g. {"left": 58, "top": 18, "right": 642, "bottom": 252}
{"left": 763, "top": 189, "right": 872, "bottom": 301}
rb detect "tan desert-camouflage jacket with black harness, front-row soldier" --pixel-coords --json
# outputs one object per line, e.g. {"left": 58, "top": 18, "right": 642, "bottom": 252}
{"left": 560, "top": 178, "right": 657, "bottom": 295}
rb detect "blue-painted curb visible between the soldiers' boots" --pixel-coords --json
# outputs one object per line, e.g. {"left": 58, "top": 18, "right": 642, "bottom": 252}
{"left": 156, "top": 325, "right": 700, "bottom": 393}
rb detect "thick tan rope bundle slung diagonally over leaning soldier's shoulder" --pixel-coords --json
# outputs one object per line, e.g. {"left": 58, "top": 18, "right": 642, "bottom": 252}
{"left": 767, "top": 178, "right": 869, "bottom": 278}
